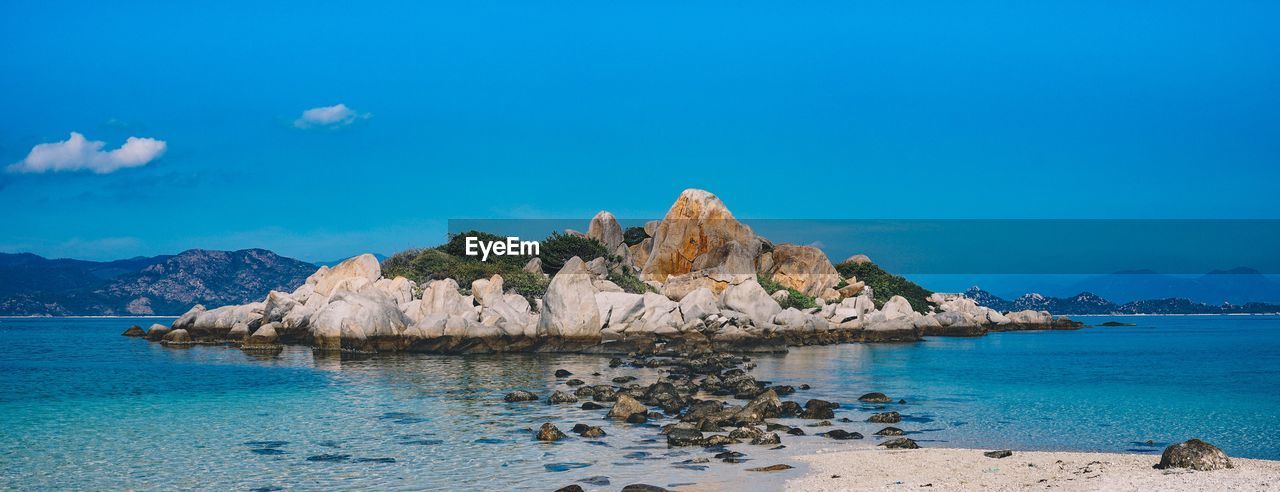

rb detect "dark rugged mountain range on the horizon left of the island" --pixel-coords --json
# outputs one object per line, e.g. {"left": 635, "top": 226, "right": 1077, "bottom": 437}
{"left": 0, "top": 250, "right": 316, "bottom": 316}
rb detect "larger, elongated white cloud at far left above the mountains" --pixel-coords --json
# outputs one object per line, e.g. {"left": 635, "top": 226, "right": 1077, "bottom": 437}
{"left": 6, "top": 132, "right": 168, "bottom": 174}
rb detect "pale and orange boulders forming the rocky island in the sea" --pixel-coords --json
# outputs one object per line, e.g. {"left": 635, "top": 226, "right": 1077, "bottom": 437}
{"left": 135, "top": 190, "right": 1080, "bottom": 354}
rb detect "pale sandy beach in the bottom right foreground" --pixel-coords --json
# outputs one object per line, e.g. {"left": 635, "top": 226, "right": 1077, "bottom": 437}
{"left": 785, "top": 448, "right": 1280, "bottom": 491}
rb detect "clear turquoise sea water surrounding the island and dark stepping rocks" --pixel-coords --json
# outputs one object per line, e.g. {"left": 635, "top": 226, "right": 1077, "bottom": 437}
{"left": 0, "top": 316, "right": 1280, "bottom": 489}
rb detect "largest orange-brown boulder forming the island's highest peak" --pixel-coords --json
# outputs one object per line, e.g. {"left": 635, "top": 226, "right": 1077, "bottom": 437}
{"left": 641, "top": 190, "right": 764, "bottom": 291}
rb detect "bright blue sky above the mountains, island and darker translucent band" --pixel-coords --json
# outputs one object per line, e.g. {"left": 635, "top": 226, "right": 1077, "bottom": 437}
{"left": 0, "top": 0, "right": 1280, "bottom": 265}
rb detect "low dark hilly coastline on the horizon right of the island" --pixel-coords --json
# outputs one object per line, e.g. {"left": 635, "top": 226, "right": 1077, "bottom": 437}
{"left": 964, "top": 286, "right": 1280, "bottom": 315}
